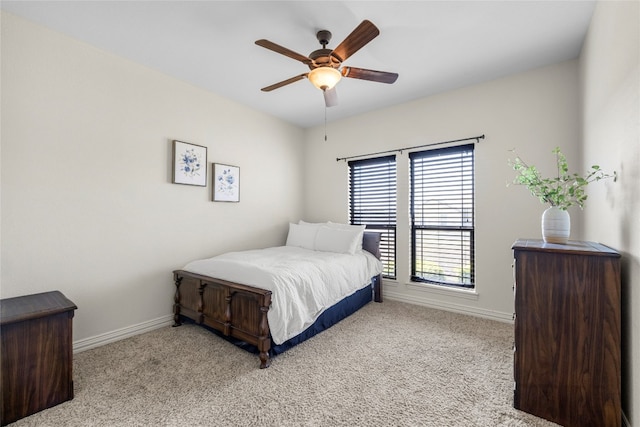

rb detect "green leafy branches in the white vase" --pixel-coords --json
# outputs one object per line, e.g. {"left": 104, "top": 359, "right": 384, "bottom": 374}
{"left": 509, "top": 147, "right": 616, "bottom": 210}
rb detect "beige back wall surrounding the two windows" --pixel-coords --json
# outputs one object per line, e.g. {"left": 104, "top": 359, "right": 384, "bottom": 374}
{"left": 305, "top": 61, "right": 581, "bottom": 321}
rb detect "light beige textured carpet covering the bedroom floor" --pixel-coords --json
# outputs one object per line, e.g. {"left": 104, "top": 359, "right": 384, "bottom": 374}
{"left": 7, "top": 301, "right": 555, "bottom": 426}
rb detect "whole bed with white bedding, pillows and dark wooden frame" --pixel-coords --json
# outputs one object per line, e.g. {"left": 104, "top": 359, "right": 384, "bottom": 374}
{"left": 173, "top": 221, "right": 382, "bottom": 368}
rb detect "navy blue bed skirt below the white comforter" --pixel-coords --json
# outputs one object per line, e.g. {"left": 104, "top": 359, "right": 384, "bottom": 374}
{"left": 181, "top": 278, "right": 377, "bottom": 357}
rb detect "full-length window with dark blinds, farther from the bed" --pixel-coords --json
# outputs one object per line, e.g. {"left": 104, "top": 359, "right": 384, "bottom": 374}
{"left": 409, "top": 145, "right": 475, "bottom": 288}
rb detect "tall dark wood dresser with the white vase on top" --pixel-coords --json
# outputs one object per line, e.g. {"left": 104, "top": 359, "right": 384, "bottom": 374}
{"left": 513, "top": 240, "right": 622, "bottom": 427}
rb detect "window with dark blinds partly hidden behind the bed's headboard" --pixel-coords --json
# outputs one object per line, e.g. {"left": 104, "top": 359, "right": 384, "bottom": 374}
{"left": 349, "top": 156, "right": 396, "bottom": 279}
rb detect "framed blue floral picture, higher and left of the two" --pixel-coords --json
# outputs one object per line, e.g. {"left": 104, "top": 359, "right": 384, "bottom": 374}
{"left": 173, "top": 141, "right": 207, "bottom": 187}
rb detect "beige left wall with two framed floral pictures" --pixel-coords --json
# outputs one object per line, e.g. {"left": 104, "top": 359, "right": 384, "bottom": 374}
{"left": 0, "top": 13, "right": 303, "bottom": 347}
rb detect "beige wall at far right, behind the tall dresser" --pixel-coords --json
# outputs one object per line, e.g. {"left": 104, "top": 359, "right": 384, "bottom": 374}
{"left": 580, "top": 1, "right": 640, "bottom": 425}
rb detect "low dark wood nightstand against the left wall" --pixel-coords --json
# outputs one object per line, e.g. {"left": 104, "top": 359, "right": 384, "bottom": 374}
{"left": 0, "top": 291, "right": 77, "bottom": 425}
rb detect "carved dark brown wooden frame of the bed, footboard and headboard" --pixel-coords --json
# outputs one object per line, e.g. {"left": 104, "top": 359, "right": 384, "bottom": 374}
{"left": 173, "top": 232, "right": 382, "bottom": 368}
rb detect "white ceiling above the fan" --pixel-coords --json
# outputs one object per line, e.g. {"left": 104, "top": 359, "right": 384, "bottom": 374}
{"left": 1, "top": 0, "right": 595, "bottom": 127}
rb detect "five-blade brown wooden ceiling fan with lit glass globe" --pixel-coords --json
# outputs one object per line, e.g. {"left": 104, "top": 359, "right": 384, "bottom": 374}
{"left": 256, "top": 20, "right": 398, "bottom": 107}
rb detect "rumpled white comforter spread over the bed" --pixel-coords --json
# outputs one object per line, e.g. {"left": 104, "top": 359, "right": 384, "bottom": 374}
{"left": 183, "top": 246, "right": 382, "bottom": 344}
